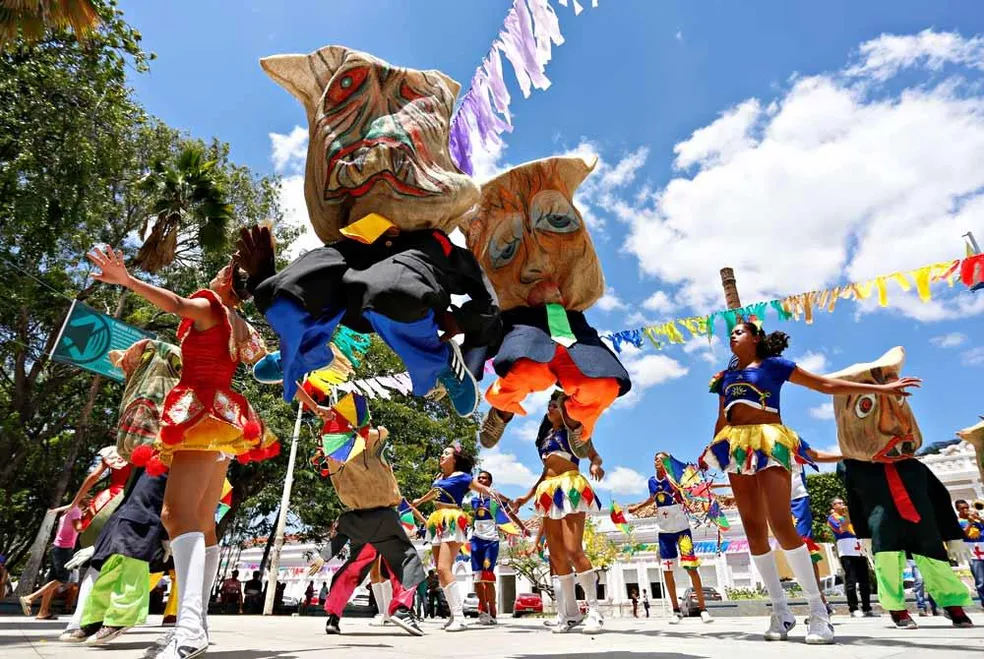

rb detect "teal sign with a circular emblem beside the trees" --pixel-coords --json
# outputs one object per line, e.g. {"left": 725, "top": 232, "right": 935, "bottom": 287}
{"left": 51, "top": 301, "right": 155, "bottom": 382}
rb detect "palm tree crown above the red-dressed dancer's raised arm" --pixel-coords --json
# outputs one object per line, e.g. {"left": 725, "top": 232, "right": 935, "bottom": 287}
{"left": 134, "top": 146, "right": 233, "bottom": 273}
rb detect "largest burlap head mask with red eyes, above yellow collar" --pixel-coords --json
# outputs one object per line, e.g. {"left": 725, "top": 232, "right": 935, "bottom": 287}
{"left": 260, "top": 46, "right": 478, "bottom": 242}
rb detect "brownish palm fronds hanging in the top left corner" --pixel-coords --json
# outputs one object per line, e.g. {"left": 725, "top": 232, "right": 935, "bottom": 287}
{"left": 0, "top": 0, "right": 99, "bottom": 49}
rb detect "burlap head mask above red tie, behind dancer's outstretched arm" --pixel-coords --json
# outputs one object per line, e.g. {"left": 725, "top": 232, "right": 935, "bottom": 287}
{"left": 828, "top": 348, "right": 922, "bottom": 462}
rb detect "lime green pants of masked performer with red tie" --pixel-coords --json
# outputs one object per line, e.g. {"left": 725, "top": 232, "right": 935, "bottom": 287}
{"left": 875, "top": 551, "right": 973, "bottom": 611}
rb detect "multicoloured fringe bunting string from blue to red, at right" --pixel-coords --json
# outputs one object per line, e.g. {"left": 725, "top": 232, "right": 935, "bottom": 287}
{"left": 601, "top": 254, "right": 984, "bottom": 353}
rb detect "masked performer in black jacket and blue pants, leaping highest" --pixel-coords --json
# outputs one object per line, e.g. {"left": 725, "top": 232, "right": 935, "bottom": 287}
{"left": 240, "top": 46, "right": 499, "bottom": 416}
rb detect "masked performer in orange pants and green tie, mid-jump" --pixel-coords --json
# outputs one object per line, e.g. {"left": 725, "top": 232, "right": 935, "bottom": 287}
{"left": 466, "top": 158, "right": 631, "bottom": 458}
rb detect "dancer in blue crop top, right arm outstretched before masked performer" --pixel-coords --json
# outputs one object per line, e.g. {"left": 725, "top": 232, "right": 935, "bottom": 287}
{"left": 700, "top": 322, "right": 919, "bottom": 644}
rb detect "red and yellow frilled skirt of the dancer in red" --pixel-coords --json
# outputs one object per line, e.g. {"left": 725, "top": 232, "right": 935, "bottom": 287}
{"left": 154, "top": 383, "right": 280, "bottom": 464}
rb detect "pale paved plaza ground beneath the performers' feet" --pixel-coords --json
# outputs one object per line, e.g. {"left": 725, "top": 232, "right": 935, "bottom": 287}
{"left": 0, "top": 613, "right": 984, "bottom": 659}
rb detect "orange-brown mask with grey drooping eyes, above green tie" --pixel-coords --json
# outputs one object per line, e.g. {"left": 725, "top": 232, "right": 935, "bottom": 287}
{"left": 466, "top": 158, "right": 605, "bottom": 311}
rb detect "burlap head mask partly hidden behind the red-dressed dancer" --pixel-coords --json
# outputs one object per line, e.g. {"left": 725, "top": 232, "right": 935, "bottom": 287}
{"left": 110, "top": 339, "right": 181, "bottom": 461}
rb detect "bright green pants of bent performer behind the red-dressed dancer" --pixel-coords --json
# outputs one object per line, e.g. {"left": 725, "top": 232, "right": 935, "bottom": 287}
{"left": 82, "top": 554, "right": 150, "bottom": 627}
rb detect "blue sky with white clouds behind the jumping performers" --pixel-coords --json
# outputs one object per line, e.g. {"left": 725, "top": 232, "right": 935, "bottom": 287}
{"left": 121, "top": 0, "right": 984, "bottom": 501}
